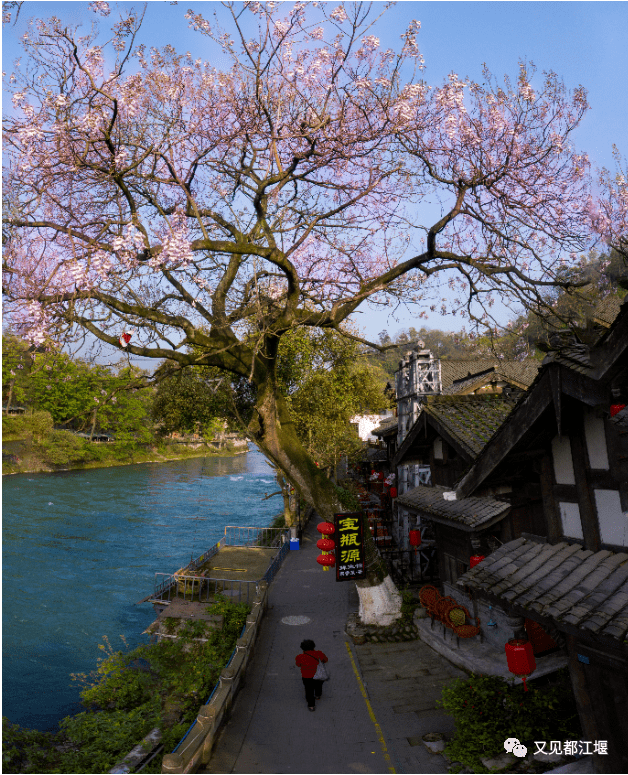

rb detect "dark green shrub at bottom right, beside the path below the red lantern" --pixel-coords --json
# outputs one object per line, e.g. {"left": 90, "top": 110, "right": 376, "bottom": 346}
{"left": 438, "top": 668, "right": 580, "bottom": 772}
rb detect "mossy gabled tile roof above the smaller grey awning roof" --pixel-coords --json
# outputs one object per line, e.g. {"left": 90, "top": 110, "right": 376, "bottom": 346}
{"left": 423, "top": 394, "right": 515, "bottom": 458}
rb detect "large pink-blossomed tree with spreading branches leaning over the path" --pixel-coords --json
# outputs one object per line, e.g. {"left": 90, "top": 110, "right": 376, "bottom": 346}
{"left": 3, "top": 2, "right": 612, "bottom": 620}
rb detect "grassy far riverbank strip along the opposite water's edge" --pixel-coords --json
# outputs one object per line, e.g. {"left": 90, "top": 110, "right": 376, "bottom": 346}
{"left": 2, "top": 431, "right": 248, "bottom": 476}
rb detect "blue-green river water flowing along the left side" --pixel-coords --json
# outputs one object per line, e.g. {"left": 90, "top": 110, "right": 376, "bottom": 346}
{"left": 2, "top": 447, "right": 281, "bottom": 731}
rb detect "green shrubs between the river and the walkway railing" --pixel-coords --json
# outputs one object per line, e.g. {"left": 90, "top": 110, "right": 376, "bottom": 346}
{"left": 3, "top": 596, "right": 250, "bottom": 773}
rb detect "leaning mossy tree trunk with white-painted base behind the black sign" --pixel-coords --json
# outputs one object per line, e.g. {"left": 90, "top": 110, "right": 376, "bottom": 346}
{"left": 248, "top": 386, "right": 401, "bottom": 626}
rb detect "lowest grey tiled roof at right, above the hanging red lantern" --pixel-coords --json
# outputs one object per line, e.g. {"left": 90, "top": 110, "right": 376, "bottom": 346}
{"left": 457, "top": 540, "right": 628, "bottom": 643}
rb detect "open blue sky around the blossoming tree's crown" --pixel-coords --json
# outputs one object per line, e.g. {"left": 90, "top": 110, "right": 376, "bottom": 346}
{"left": 2, "top": 0, "right": 628, "bottom": 352}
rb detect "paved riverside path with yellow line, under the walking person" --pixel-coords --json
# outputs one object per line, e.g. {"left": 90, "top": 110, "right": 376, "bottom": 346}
{"left": 201, "top": 518, "right": 462, "bottom": 773}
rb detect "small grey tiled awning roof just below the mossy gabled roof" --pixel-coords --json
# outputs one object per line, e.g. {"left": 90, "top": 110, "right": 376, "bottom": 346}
{"left": 397, "top": 485, "right": 510, "bottom": 528}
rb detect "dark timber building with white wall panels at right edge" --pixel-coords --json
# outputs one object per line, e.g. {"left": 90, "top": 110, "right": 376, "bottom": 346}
{"left": 446, "top": 302, "right": 628, "bottom": 773}
